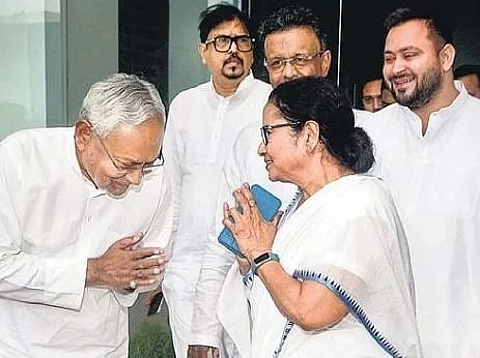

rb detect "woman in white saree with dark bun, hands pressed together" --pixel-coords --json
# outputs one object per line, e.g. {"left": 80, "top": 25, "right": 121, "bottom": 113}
{"left": 218, "top": 78, "right": 422, "bottom": 358}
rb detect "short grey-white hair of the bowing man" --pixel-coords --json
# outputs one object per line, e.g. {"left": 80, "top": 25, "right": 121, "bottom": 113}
{"left": 79, "top": 73, "right": 165, "bottom": 138}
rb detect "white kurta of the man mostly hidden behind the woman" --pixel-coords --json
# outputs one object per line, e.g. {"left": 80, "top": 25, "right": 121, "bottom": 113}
{"left": 192, "top": 110, "right": 376, "bottom": 354}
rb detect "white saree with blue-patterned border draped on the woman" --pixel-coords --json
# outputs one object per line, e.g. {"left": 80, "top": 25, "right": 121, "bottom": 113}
{"left": 219, "top": 175, "right": 421, "bottom": 358}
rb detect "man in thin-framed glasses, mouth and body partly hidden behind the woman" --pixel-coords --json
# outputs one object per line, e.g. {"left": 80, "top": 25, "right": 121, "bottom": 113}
{"left": 188, "top": 5, "right": 376, "bottom": 358}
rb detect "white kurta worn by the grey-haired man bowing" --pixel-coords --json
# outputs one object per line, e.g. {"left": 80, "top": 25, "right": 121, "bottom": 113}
{"left": 0, "top": 128, "right": 173, "bottom": 358}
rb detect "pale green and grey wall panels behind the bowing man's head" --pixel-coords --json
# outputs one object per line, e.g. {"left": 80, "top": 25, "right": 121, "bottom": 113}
{"left": 0, "top": 0, "right": 118, "bottom": 139}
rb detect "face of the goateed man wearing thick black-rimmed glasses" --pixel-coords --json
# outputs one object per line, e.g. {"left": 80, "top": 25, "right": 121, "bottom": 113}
{"left": 198, "top": 19, "right": 253, "bottom": 83}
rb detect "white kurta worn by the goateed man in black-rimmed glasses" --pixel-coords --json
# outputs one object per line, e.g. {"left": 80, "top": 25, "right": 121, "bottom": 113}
{"left": 163, "top": 74, "right": 271, "bottom": 357}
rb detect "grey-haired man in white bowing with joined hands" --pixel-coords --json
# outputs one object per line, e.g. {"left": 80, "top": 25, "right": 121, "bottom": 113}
{"left": 0, "top": 74, "right": 173, "bottom": 357}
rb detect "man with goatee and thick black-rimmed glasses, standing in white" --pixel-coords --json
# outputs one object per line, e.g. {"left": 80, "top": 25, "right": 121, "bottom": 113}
{"left": 163, "top": 4, "right": 271, "bottom": 357}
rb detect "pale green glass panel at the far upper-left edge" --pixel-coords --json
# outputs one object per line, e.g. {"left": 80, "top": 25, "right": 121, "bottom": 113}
{"left": 0, "top": 1, "right": 46, "bottom": 139}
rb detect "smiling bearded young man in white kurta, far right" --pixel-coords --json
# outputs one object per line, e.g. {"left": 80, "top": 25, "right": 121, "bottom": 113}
{"left": 364, "top": 9, "right": 480, "bottom": 358}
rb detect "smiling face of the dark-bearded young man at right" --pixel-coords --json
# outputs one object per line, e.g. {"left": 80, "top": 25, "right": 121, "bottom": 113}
{"left": 383, "top": 20, "right": 444, "bottom": 110}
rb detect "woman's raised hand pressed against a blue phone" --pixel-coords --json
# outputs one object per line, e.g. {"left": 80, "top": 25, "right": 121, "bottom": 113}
{"left": 223, "top": 183, "right": 282, "bottom": 261}
